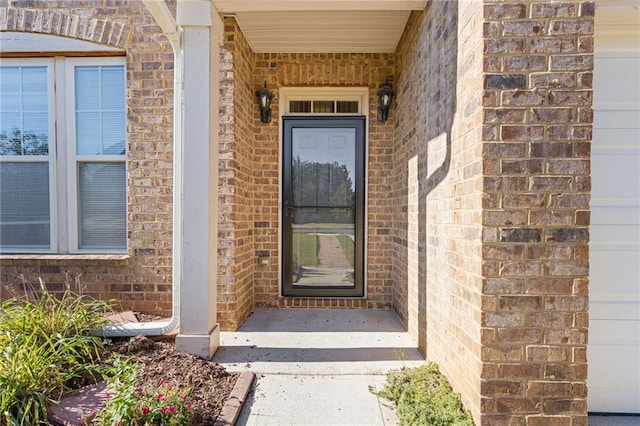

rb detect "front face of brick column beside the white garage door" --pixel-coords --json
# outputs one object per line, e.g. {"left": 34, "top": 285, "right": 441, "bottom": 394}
{"left": 481, "top": 1, "right": 594, "bottom": 426}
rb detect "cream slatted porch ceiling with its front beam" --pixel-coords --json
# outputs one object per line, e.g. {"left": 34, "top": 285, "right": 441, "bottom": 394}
{"left": 212, "top": 0, "right": 427, "bottom": 53}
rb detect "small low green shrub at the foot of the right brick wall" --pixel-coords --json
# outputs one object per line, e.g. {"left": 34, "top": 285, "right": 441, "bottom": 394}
{"left": 378, "top": 362, "right": 473, "bottom": 426}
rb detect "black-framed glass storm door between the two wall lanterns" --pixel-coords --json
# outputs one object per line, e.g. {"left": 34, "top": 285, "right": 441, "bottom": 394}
{"left": 282, "top": 117, "right": 365, "bottom": 297}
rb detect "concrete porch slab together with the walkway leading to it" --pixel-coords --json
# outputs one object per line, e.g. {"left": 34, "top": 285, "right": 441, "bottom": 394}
{"left": 214, "top": 309, "right": 424, "bottom": 425}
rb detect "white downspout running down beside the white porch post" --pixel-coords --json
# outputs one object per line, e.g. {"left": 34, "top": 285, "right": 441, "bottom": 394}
{"left": 102, "top": 0, "right": 183, "bottom": 337}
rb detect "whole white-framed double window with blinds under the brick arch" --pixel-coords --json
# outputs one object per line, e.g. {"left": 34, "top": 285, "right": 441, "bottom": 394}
{"left": 0, "top": 57, "right": 126, "bottom": 253}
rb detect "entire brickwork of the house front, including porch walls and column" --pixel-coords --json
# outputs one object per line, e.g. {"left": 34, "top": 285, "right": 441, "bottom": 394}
{"left": 0, "top": 0, "right": 595, "bottom": 426}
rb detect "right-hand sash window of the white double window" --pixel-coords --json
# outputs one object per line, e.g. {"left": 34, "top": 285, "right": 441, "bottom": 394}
{"left": 72, "top": 62, "right": 127, "bottom": 250}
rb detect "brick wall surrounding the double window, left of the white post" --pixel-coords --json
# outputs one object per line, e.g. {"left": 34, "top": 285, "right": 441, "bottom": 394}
{"left": 0, "top": 0, "right": 175, "bottom": 315}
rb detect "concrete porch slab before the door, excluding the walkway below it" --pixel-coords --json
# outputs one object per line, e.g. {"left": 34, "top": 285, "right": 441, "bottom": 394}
{"left": 214, "top": 309, "right": 424, "bottom": 375}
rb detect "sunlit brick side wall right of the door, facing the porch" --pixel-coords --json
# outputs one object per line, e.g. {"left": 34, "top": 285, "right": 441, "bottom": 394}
{"left": 392, "top": 2, "right": 482, "bottom": 421}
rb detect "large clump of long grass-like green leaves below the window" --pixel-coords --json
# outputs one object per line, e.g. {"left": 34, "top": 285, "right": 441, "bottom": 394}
{"left": 0, "top": 281, "right": 111, "bottom": 425}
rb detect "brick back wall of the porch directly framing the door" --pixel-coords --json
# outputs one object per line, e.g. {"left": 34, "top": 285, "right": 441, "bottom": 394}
{"left": 253, "top": 53, "right": 394, "bottom": 308}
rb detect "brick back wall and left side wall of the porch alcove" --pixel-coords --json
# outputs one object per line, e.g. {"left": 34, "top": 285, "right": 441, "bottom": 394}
{"left": 218, "top": 19, "right": 395, "bottom": 322}
